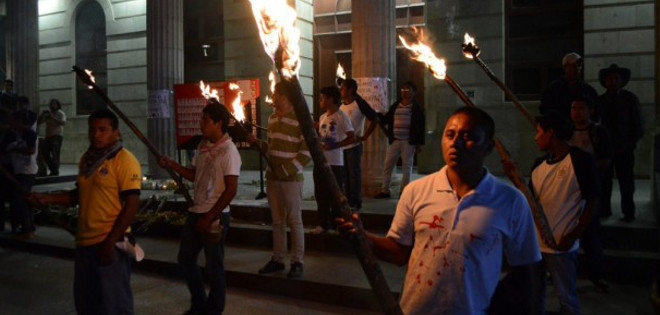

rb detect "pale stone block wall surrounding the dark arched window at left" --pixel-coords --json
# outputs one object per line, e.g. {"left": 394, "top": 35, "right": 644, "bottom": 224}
{"left": 39, "top": 0, "right": 147, "bottom": 163}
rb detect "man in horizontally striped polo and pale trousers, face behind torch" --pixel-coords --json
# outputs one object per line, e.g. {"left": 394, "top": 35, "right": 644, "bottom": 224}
{"left": 259, "top": 81, "right": 311, "bottom": 278}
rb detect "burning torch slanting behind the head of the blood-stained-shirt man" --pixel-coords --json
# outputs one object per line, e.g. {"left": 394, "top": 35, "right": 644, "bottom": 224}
{"left": 399, "top": 30, "right": 557, "bottom": 248}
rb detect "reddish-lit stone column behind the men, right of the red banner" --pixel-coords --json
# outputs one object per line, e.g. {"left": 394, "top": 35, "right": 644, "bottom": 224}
{"left": 351, "top": 0, "right": 396, "bottom": 196}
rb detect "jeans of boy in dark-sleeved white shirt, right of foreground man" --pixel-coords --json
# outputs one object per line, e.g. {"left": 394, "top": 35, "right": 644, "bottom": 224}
{"left": 533, "top": 251, "right": 580, "bottom": 315}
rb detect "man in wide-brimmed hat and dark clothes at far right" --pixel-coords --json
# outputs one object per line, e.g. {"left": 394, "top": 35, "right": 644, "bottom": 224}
{"left": 598, "top": 64, "right": 644, "bottom": 222}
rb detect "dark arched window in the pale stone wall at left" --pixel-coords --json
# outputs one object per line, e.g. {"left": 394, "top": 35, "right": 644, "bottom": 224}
{"left": 76, "top": 1, "right": 108, "bottom": 115}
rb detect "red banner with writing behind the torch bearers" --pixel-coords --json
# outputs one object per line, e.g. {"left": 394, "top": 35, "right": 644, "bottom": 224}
{"left": 174, "top": 79, "right": 260, "bottom": 149}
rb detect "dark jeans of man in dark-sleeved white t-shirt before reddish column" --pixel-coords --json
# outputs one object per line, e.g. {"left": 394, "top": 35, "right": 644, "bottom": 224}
{"left": 344, "top": 143, "right": 362, "bottom": 210}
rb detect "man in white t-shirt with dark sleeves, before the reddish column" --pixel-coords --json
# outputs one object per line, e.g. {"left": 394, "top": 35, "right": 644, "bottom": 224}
{"left": 339, "top": 79, "right": 378, "bottom": 211}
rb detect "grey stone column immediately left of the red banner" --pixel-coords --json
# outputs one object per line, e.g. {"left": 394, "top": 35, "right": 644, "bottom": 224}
{"left": 147, "top": 0, "right": 183, "bottom": 178}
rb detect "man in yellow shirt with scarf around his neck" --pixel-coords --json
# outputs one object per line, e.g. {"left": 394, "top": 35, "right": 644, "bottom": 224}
{"left": 30, "top": 109, "right": 142, "bottom": 314}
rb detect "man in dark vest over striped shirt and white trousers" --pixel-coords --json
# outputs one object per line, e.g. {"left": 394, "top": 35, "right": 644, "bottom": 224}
{"left": 374, "top": 81, "right": 426, "bottom": 199}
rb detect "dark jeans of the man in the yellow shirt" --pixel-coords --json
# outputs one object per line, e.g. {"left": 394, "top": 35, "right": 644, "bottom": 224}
{"left": 73, "top": 244, "right": 133, "bottom": 315}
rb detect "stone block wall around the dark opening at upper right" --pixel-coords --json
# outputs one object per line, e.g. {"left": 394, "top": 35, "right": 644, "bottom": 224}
{"left": 418, "top": 0, "right": 655, "bottom": 177}
